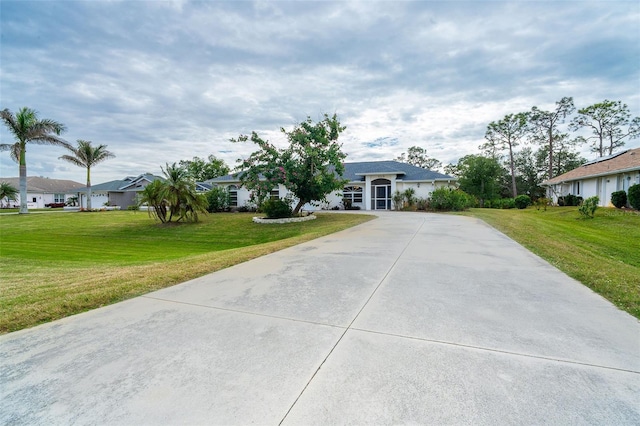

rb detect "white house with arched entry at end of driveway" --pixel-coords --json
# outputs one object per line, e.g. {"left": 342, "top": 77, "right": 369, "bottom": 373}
{"left": 207, "top": 161, "right": 457, "bottom": 210}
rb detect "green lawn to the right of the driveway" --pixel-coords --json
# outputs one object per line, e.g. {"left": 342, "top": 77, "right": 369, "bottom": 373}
{"left": 464, "top": 207, "right": 640, "bottom": 318}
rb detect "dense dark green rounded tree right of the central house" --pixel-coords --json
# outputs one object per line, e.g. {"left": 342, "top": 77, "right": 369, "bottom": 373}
{"left": 457, "top": 155, "right": 503, "bottom": 207}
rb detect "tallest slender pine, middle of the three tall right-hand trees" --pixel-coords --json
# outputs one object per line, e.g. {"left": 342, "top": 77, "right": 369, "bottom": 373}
{"left": 529, "top": 97, "right": 576, "bottom": 179}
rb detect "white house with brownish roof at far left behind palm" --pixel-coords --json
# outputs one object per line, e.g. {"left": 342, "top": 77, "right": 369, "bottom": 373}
{"left": 0, "top": 176, "right": 85, "bottom": 209}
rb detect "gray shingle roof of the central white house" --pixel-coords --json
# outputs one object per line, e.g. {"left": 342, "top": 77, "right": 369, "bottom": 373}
{"left": 207, "top": 161, "right": 456, "bottom": 184}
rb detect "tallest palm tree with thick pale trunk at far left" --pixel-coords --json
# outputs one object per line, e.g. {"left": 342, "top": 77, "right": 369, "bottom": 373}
{"left": 0, "top": 107, "right": 71, "bottom": 214}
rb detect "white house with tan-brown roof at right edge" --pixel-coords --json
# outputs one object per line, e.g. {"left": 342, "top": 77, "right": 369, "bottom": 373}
{"left": 542, "top": 148, "right": 640, "bottom": 207}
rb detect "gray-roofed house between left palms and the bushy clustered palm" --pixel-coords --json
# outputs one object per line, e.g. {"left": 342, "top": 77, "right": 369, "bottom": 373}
{"left": 77, "top": 173, "right": 162, "bottom": 210}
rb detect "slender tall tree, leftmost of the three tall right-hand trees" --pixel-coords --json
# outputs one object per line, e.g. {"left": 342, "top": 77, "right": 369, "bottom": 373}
{"left": 480, "top": 112, "right": 528, "bottom": 198}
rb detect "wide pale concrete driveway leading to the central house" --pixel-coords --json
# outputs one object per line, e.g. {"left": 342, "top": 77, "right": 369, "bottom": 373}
{"left": 0, "top": 213, "right": 640, "bottom": 425}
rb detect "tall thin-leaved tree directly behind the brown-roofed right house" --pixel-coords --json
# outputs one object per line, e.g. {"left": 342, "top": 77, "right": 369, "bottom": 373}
{"left": 570, "top": 99, "right": 640, "bottom": 157}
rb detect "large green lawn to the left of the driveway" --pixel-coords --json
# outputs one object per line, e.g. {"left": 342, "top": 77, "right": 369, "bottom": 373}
{"left": 0, "top": 211, "right": 374, "bottom": 334}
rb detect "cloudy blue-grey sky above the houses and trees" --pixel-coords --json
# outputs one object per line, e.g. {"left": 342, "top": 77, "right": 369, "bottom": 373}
{"left": 0, "top": 0, "right": 640, "bottom": 183}
